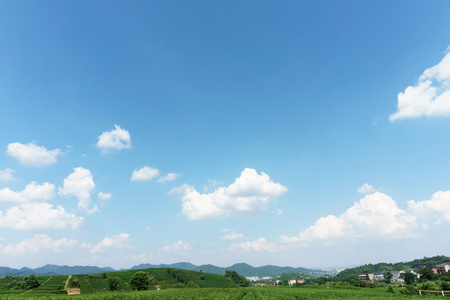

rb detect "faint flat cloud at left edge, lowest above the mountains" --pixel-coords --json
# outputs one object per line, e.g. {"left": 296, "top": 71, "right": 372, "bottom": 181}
{"left": 0, "top": 234, "right": 78, "bottom": 255}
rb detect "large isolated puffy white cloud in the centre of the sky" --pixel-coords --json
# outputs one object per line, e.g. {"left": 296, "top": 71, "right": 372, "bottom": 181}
{"left": 170, "top": 168, "right": 287, "bottom": 220}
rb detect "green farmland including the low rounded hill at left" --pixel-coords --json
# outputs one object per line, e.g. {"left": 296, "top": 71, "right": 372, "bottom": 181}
{"left": 0, "top": 268, "right": 442, "bottom": 300}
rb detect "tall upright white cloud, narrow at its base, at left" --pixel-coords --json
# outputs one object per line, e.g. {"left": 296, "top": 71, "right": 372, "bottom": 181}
{"left": 58, "top": 167, "right": 98, "bottom": 213}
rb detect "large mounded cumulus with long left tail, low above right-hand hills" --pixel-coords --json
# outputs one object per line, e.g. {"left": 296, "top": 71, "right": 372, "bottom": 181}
{"left": 280, "top": 192, "right": 416, "bottom": 244}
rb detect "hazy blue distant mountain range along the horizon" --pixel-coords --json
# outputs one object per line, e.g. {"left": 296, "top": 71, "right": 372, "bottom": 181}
{"left": 0, "top": 262, "right": 327, "bottom": 277}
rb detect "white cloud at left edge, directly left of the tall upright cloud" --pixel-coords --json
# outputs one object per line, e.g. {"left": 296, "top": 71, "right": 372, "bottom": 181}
{"left": 0, "top": 181, "right": 55, "bottom": 204}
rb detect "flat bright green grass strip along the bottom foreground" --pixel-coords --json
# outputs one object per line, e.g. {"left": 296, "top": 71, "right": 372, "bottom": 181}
{"left": 0, "top": 286, "right": 440, "bottom": 300}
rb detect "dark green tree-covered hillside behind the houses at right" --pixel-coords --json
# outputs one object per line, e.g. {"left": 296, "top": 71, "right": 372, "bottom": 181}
{"left": 337, "top": 255, "right": 450, "bottom": 278}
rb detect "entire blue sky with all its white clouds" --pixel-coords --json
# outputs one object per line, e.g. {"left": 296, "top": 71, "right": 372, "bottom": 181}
{"left": 0, "top": 1, "right": 450, "bottom": 268}
